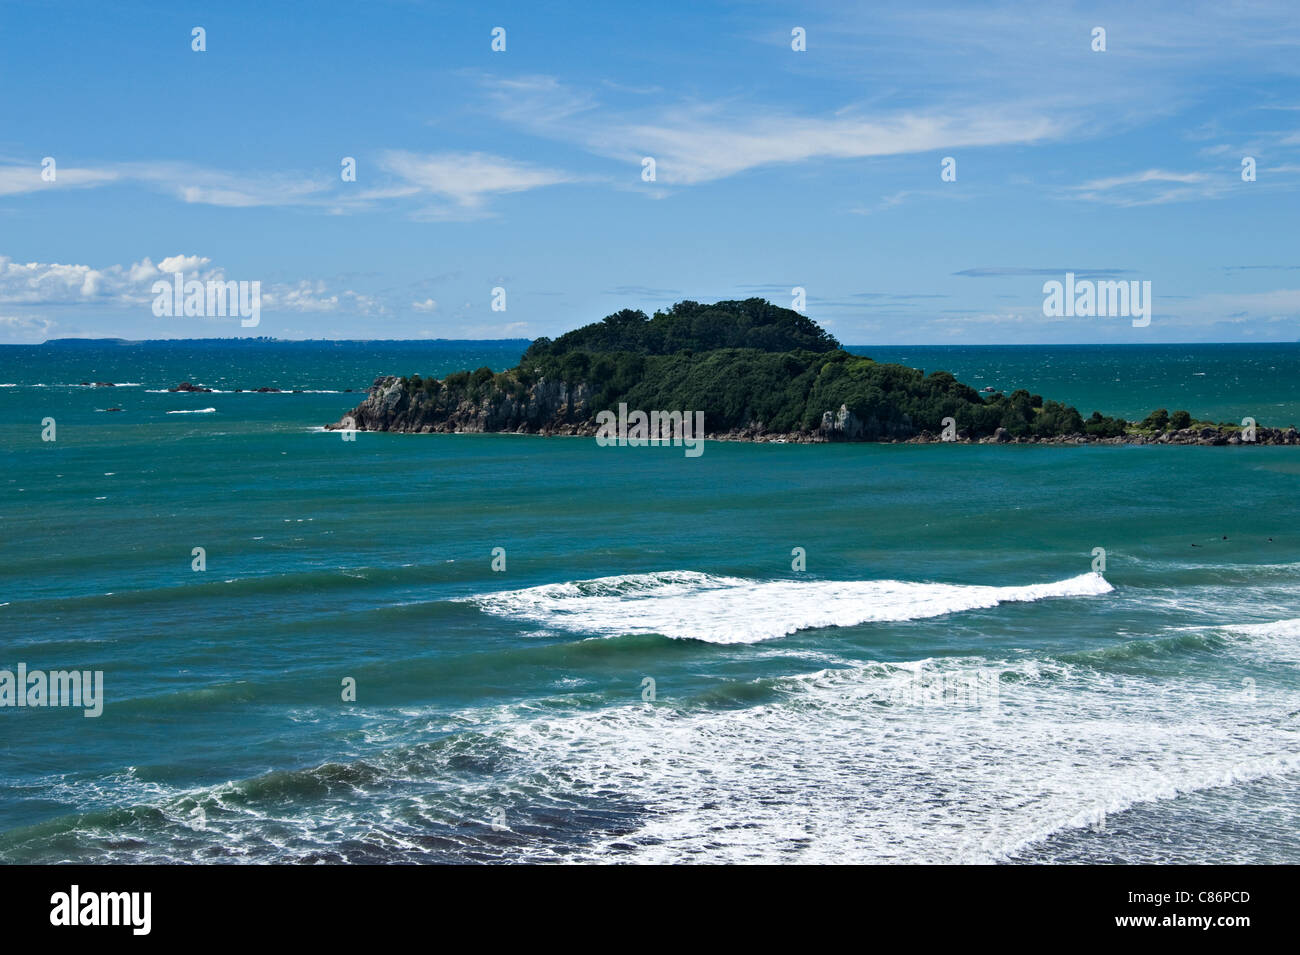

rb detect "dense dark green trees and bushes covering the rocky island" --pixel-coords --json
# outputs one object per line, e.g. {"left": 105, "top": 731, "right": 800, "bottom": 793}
{"left": 400, "top": 299, "right": 1138, "bottom": 439}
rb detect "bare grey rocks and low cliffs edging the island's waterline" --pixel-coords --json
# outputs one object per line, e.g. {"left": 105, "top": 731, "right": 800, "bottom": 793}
{"left": 325, "top": 376, "right": 1300, "bottom": 447}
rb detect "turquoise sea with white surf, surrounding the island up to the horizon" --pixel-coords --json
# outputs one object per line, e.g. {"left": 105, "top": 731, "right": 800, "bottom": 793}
{"left": 0, "top": 342, "right": 1300, "bottom": 863}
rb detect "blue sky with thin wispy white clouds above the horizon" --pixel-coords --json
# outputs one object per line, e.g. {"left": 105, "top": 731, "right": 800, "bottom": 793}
{"left": 0, "top": 0, "right": 1300, "bottom": 344}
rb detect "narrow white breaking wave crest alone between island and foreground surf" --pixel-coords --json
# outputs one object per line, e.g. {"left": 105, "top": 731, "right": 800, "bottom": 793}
{"left": 471, "top": 570, "right": 1113, "bottom": 643}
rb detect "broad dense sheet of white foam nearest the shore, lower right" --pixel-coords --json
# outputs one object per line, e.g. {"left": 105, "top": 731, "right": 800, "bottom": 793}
{"left": 480, "top": 657, "right": 1300, "bottom": 863}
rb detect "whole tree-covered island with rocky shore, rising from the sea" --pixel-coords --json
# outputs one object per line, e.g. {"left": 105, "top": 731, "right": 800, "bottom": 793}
{"left": 325, "top": 299, "right": 1300, "bottom": 446}
